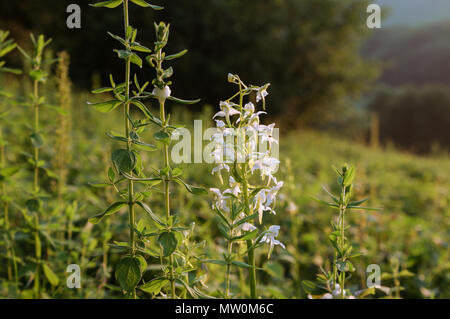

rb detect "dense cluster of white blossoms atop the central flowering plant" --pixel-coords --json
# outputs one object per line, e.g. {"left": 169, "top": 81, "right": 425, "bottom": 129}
{"left": 211, "top": 74, "right": 283, "bottom": 234}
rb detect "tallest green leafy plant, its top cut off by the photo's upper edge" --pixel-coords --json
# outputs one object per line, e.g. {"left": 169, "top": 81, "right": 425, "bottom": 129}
{"left": 89, "top": 0, "right": 162, "bottom": 298}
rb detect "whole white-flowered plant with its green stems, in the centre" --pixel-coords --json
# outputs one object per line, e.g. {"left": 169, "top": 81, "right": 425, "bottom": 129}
{"left": 209, "top": 74, "right": 285, "bottom": 298}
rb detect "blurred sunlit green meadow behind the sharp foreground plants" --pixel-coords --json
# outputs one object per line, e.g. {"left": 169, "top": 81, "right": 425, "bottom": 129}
{"left": 0, "top": 68, "right": 450, "bottom": 298}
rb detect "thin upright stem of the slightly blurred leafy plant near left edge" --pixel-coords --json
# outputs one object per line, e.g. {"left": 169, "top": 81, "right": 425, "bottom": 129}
{"left": 33, "top": 81, "right": 42, "bottom": 298}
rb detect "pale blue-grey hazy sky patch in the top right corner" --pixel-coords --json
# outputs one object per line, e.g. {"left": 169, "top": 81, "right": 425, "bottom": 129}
{"left": 372, "top": 0, "right": 450, "bottom": 26}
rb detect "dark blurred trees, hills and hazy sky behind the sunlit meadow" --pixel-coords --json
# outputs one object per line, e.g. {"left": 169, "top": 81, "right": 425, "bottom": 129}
{"left": 0, "top": 0, "right": 450, "bottom": 153}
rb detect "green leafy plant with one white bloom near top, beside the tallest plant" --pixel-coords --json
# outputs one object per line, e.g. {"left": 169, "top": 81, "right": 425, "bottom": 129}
{"left": 136, "top": 22, "right": 208, "bottom": 299}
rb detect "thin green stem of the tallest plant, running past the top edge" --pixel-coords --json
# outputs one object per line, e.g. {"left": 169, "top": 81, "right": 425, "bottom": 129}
{"left": 123, "top": 0, "right": 136, "bottom": 299}
